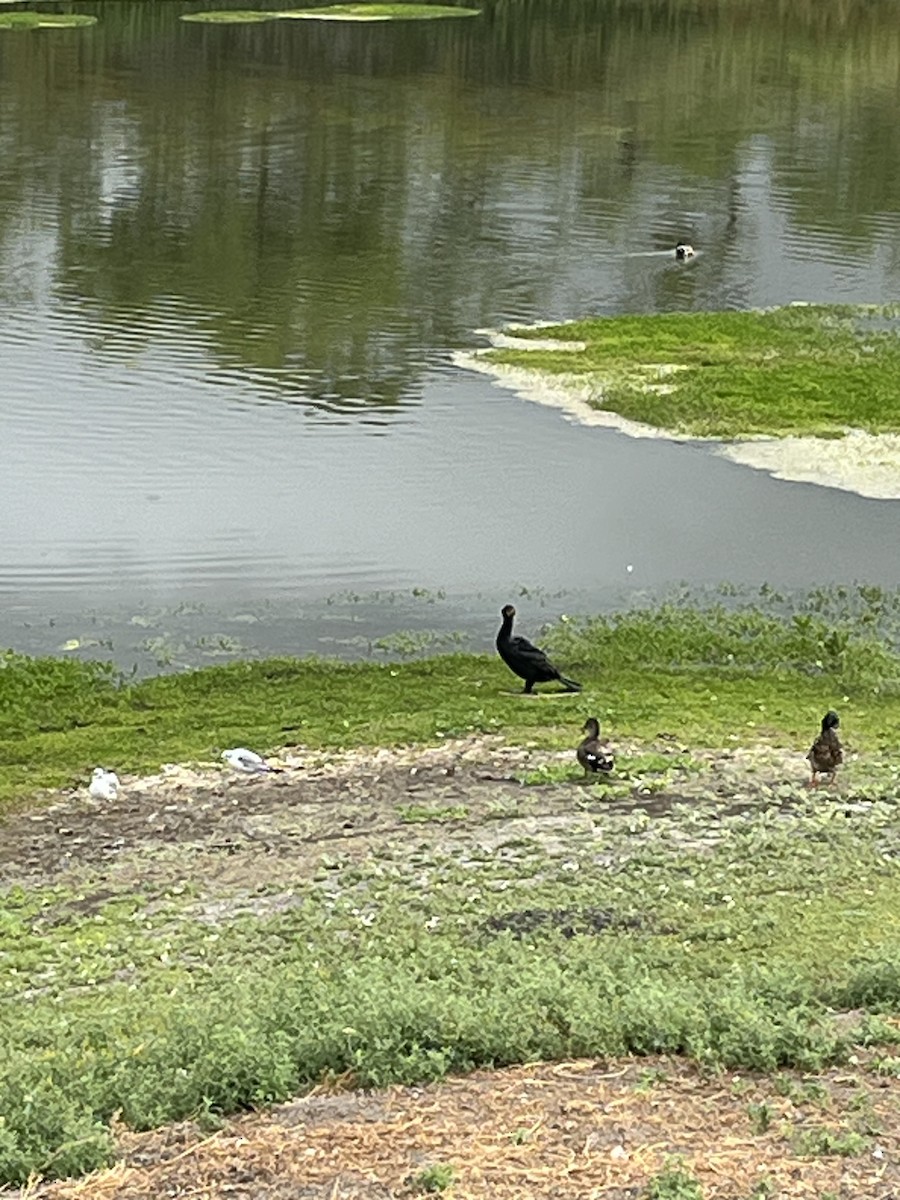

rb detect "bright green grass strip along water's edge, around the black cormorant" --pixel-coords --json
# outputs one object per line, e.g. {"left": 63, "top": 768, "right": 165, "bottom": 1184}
{"left": 0, "top": 587, "right": 900, "bottom": 802}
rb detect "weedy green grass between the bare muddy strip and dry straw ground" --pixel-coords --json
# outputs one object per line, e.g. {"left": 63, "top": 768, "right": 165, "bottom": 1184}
{"left": 0, "top": 805, "right": 900, "bottom": 1182}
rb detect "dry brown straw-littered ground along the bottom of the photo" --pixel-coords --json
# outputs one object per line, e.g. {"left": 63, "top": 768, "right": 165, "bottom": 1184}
{"left": 16, "top": 1060, "right": 900, "bottom": 1200}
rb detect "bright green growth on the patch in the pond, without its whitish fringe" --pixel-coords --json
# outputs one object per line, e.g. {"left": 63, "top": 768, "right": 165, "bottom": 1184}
{"left": 482, "top": 305, "right": 900, "bottom": 438}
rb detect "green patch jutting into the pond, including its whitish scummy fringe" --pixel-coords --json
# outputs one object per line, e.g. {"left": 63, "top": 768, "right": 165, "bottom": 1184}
{"left": 455, "top": 305, "right": 900, "bottom": 499}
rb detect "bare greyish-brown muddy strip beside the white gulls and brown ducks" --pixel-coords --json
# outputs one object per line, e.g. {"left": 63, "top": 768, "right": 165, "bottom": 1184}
{"left": 0, "top": 737, "right": 804, "bottom": 897}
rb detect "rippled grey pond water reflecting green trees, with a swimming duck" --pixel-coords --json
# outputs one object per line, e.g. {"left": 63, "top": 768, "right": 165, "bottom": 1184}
{"left": 0, "top": 0, "right": 900, "bottom": 667}
